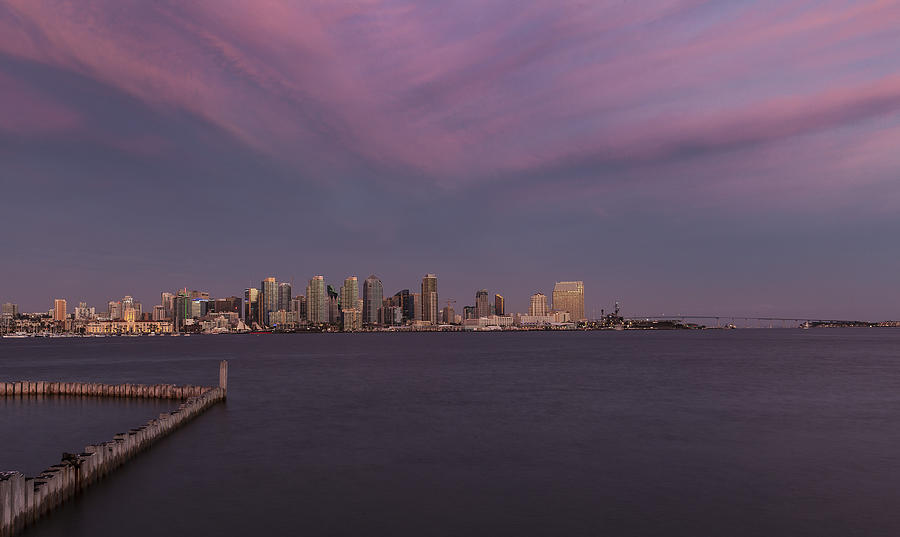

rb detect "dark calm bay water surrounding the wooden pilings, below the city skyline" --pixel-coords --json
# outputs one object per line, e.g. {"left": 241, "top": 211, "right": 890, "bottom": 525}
{"left": 0, "top": 329, "right": 900, "bottom": 537}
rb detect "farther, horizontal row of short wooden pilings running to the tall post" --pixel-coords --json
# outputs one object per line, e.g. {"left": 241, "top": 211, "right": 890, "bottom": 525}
{"left": 0, "top": 380, "right": 209, "bottom": 399}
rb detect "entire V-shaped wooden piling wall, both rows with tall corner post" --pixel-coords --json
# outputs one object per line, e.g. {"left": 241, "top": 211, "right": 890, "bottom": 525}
{"left": 0, "top": 361, "right": 228, "bottom": 537}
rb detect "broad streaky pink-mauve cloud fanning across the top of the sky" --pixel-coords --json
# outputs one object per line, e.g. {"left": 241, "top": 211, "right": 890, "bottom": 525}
{"left": 0, "top": 0, "right": 900, "bottom": 197}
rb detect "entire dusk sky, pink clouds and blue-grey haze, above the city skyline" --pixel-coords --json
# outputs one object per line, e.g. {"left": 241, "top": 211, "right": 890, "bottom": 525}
{"left": 0, "top": 0, "right": 900, "bottom": 319}
